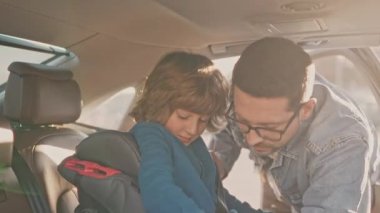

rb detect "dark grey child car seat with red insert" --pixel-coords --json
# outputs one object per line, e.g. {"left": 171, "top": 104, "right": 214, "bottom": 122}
{"left": 59, "top": 130, "right": 144, "bottom": 213}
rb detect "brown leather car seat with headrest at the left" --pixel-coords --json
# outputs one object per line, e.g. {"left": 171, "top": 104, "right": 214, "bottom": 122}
{"left": 4, "top": 62, "right": 87, "bottom": 213}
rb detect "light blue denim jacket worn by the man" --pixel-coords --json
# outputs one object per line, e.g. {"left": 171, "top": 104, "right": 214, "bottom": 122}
{"left": 209, "top": 75, "right": 378, "bottom": 213}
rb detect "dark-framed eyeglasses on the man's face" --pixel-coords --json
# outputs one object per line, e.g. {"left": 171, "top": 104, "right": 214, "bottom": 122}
{"left": 225, "top": 102, "right": 303, "bottom": 142}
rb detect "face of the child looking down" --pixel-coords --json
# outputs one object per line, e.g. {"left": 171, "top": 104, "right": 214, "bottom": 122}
{"left": 165, "top": 109, "right": 210, "bottom": 145}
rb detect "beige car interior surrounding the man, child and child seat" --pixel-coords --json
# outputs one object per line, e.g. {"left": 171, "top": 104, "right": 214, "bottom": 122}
{"left": 0, "top": 0, "right": 380, "bottom": 213}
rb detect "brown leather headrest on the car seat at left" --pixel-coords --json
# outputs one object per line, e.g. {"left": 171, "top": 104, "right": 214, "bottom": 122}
{"left": 3, "top": 62, "right": 81, "bottom": 125}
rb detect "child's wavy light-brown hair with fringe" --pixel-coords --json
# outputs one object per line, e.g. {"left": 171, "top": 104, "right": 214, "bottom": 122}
{"left": 130, "top": 52, "right": 228, "bottom": 131}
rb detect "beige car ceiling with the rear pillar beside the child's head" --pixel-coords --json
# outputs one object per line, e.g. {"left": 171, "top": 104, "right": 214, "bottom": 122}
{"left": 0, "top": 0, "right": 380, "bottom": 103}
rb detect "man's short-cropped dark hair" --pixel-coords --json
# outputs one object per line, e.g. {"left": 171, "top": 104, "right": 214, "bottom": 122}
{"left": 232, "top": 37, "right": 314, "bottom": 110}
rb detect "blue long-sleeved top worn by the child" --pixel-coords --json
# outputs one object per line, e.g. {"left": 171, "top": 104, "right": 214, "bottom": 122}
{"left": 131, "top": 122, "right": 217, "bottom": 213}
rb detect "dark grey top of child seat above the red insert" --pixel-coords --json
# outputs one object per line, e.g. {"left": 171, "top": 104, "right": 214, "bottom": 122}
{"left": 76, "top": 130, "right": 140, "bottom": 179}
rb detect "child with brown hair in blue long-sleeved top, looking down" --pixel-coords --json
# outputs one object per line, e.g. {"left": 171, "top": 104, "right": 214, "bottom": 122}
{"left": 131, "top": 52, "right": 228, "bottom": 213}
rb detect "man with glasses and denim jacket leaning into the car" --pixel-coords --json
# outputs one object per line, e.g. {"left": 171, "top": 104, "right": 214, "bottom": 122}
{"left": 210, "top": 37, "right": 377, "bottom": 213}
